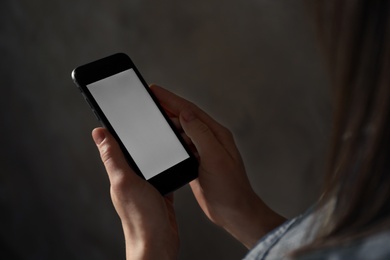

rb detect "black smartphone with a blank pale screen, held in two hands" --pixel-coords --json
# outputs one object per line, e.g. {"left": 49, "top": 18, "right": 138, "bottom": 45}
{"left": 72, "top": 53, "right": 198, "bottom": 195}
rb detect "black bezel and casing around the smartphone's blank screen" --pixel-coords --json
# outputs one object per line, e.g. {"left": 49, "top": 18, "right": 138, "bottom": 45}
{"left": 72, "top": 53, "right": 198, "bottom": 195}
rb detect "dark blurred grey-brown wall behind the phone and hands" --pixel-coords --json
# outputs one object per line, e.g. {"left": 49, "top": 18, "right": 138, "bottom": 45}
{"left": 0, "top": 0, "right": 331, "bottom": 259}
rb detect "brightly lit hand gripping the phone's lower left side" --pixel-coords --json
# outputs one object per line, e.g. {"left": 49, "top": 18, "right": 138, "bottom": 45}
{"left": 92, "top": 128, "right": 179, "bottom": 259}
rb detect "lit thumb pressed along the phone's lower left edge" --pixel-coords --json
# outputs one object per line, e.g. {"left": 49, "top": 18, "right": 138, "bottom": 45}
{"left": 92, "top": 127, "right": 139, "bottom": 189}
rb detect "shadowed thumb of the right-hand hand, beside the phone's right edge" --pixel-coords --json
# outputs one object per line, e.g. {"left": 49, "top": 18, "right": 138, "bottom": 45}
{"left": 180, "top": 110, "right": 224, "bottom": 158}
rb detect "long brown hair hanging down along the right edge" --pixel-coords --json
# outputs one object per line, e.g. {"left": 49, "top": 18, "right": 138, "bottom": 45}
{"left": 296, "top": 0, "right": 390, "bottom": 254}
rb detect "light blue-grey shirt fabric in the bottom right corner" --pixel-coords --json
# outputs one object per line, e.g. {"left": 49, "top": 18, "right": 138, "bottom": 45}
{"left": 244, "top": 207, "right": 390, "bottom": 260}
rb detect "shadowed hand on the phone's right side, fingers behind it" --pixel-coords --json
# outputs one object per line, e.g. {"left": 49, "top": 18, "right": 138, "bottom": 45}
{"left": 151, "top": 85, "right": 285, "bottom": 248}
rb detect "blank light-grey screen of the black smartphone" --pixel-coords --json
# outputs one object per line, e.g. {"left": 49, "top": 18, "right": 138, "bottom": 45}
{"left": 87, "top": 69, "right": 190, "bottom": 180}
